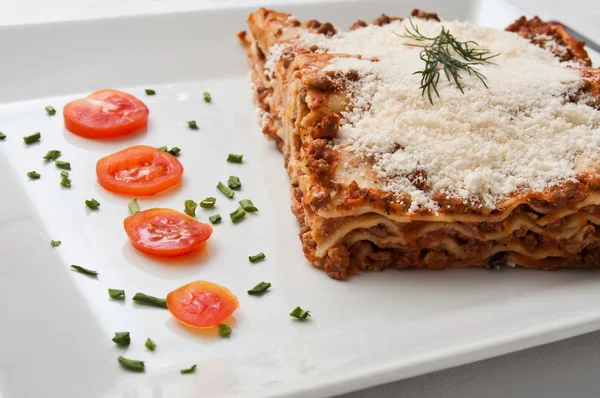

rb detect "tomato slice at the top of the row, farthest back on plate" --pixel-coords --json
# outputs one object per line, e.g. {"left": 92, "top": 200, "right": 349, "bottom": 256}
{"left": 63, "top": 90, "right": 149, "bottom": 139}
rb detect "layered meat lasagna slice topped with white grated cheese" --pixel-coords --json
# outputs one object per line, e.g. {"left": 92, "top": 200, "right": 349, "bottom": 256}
{"left": 239, "top": 8, "right": 600, "bottom": 279}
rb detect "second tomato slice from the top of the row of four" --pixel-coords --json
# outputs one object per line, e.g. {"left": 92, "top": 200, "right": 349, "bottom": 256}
{"left": 96, "top": 145, "right": 183, "bottom": 196}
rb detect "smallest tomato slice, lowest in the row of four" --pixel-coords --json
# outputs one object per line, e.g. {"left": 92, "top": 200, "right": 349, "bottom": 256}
{"left": 167, "top": 281, "right": 240, "bottom": 328}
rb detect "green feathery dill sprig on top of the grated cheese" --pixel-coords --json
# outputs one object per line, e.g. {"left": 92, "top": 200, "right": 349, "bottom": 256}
{"left": 398, "top": 20, "right": 499, "bottom": 105}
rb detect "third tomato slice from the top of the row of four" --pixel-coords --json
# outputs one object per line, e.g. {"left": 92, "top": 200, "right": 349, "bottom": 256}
{"left": 123, "top": 209, "right": 212, "bottom": 257}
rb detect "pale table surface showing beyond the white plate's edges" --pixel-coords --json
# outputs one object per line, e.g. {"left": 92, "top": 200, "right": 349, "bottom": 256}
{"left": 0, "top": 0, "right": 600, "bottom": 398}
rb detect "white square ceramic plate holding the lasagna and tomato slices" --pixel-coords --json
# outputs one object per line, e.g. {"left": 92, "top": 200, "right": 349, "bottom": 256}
{"left": 0, "top": 0, "right": 600, "bottom": 398}
